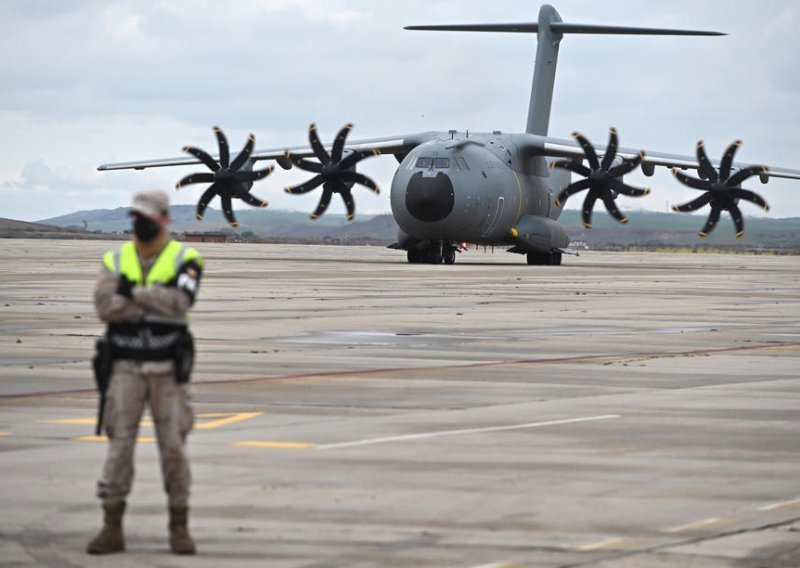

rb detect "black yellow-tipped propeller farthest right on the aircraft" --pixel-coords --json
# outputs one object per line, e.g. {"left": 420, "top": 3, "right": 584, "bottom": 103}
{"left": 672, "top": 140, "right": 769, "bottom": 239}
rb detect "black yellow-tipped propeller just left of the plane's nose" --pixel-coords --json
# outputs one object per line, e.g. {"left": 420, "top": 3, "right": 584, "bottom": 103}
{"left": 285, "top": 123, "right": 380, "bottom": 221}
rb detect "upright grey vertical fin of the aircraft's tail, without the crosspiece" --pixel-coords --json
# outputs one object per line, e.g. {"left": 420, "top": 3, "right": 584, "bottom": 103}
{"left": 525, "top": 4, "right": 563, "bottom": 136}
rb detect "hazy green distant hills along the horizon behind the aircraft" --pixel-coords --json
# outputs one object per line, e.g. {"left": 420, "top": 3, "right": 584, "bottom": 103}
{"left": 23, "top": 205, "right": 800, "bottom": 250}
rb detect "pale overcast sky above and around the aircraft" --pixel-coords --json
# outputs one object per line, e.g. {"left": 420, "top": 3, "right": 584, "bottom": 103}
{"left": 0, "top": 0, "right": 800, "bottom": 221}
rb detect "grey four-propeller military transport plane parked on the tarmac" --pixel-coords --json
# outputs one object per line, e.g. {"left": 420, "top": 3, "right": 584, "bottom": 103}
{"left": 98, "top": 5, "right": 800, "bottom": 265}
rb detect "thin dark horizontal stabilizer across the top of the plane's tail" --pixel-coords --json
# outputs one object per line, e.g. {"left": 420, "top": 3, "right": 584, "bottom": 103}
{"left": 404, "top": 22, "right": 727, "bottom": 36}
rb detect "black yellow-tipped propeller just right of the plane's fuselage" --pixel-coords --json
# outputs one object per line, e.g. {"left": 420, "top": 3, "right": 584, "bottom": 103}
{"left": 550, "top": 126, "right": 650, "bottom": 229}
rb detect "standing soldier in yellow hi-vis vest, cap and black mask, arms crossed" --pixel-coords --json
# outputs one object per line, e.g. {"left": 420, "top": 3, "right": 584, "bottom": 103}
{"left": 86, "top": 190, "right": 203, "bottom": 554}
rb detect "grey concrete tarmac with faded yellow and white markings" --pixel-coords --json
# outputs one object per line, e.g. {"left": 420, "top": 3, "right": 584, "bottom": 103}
{"left": 0, "top": 240, "right": 800, "bottom": 568}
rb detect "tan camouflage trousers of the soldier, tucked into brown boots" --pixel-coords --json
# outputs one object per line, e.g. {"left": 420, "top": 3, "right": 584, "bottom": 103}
{"left": 97, "top": 361, "right": 194, "bottom": 506}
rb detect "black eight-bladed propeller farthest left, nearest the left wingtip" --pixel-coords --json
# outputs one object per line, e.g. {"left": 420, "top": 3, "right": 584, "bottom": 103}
{"left": 175, "top": 126, "right": 274, "bottom": 227}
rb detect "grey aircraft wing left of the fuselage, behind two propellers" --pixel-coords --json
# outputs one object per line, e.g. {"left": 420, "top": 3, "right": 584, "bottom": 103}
{"left": 97, "top": 132, "right": 444, "bottom": 171}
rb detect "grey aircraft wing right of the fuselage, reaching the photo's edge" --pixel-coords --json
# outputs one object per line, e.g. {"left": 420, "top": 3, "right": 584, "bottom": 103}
{"left": 532, "top": 134, "right": 800, "bottom": 179}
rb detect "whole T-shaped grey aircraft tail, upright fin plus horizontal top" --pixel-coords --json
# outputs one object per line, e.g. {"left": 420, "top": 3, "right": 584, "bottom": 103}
{"left": 405, "top": 4, "right": 725, "bottom": 136}
